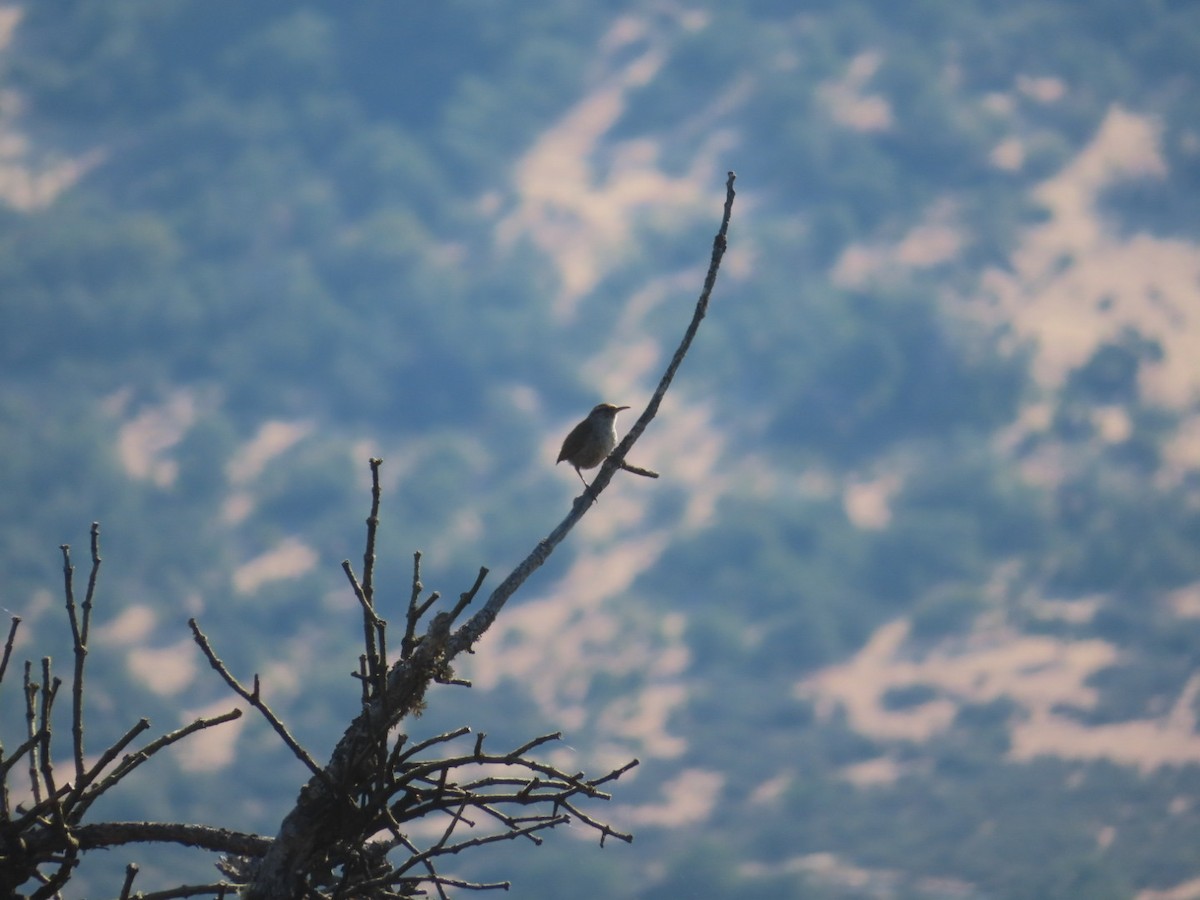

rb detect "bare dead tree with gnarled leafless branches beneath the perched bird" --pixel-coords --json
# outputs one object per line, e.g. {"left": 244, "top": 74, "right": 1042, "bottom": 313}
{"left": 0, "top": 172, "right": 734, "bottom": 900}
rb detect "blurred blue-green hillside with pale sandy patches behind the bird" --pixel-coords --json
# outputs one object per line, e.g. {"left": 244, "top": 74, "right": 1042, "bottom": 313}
{"left": 0, "top": 0, "right": 1200, "bottom": 900}
